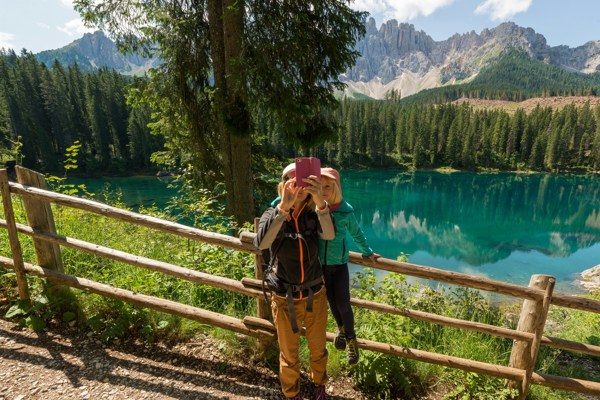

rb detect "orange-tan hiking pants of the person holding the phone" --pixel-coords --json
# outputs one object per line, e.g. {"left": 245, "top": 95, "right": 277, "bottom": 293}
{"left": 271, "top": 286, "right": 327, "bottom": 397}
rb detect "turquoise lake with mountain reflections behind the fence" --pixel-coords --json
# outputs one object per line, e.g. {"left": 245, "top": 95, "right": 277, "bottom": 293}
{"left": 69, "top": 170, "right": 600, "bottom": 293}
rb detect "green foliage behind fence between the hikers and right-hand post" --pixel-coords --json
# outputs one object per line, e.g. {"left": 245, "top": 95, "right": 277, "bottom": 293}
{"left": 350, "top": 269, "right": 512, "bottom": 400}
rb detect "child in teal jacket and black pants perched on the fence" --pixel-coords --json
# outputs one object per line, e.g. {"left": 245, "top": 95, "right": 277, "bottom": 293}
{"left": 319, "top": 168, "right": 381, "bottom": 364}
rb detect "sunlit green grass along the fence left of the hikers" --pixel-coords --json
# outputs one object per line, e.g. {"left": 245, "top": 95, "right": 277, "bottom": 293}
{"left": 0, "top": 188, "right": 255, "bottom": 340}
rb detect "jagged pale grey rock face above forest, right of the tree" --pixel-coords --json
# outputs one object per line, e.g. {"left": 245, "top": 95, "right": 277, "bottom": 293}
{"left": 343, "top": 18, "right": 600, "bottom": 98}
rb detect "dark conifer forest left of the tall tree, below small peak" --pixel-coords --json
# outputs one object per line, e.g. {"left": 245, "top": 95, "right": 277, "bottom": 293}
{"left": 0, "top": 50, "right": 163, "bottom": 174}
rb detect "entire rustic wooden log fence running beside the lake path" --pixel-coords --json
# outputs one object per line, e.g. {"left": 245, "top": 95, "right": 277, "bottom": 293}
{"left": 0, "top": 167, "right": 600, "bottom": 399}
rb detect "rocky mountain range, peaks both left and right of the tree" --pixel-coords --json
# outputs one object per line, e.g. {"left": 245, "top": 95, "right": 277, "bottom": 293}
{"left": 36, "top": 18, "right": 600, "bottom": 99}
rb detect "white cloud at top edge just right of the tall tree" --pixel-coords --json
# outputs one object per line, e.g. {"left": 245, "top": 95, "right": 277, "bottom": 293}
{"left": 352, "top": 0, "right": 454, "bottom": 22}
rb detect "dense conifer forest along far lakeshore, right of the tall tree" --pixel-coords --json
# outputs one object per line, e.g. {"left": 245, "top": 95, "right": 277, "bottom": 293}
{"left": 264, "top": 100, "right": 600, "bottom": 171}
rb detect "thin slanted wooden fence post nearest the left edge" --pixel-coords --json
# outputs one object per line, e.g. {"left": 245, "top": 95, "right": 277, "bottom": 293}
{"left": 0, "top": 169, "right": 29, "bottom": 301}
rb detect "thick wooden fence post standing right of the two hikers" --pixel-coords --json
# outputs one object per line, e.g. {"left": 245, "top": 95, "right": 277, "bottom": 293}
{"left": 509, "top": 275, "right": 556, "bottom": 400}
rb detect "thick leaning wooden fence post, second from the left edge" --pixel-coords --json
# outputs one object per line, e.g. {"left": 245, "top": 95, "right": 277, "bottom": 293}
{"left": 15, "top": 166, "right": 68, "bottom": 293}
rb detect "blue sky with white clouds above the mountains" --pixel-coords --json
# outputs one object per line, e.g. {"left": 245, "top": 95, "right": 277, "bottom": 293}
{"left": 0, "top": 0, "right": 600, "bottom": 53}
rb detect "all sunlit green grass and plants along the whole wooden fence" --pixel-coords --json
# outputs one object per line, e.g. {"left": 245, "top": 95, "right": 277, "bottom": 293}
{"left": 0, "top": 189, "right": 600, "bottom": 400}
